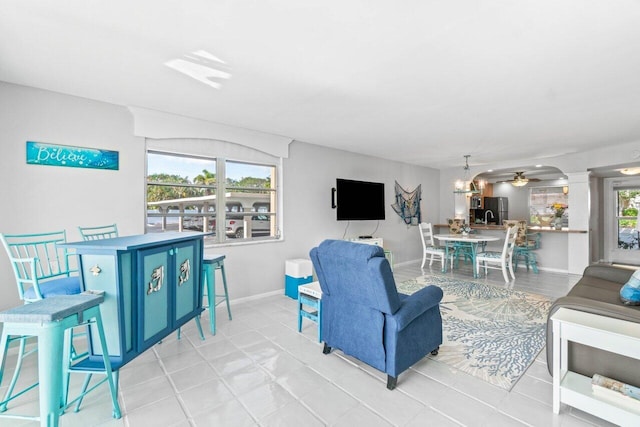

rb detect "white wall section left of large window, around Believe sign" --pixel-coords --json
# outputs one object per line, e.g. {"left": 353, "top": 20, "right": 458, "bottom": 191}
{"left": 0, "top": 83, "right": 145, "bottom": 309}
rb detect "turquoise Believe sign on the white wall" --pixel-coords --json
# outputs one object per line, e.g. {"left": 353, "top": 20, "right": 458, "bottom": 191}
{"left": 27, "top": 141, "right": 118, "bottom": 170}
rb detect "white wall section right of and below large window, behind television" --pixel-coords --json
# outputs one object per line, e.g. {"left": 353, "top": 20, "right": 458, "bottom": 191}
{"left": 206, "top": 141, "right": 439, "bottom": 300}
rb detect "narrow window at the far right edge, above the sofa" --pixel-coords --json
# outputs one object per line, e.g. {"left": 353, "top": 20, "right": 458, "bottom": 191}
{"left": 616, "top": 188, "right": 640, "bottom": 250}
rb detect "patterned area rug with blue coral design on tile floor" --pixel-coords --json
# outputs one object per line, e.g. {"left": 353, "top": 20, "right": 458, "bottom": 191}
{"left": 398, "top": 275, "right": 552, "bottom": 390}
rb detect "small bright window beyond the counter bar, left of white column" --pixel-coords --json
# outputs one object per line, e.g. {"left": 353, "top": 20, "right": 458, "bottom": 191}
{"left": 529, "top": 186, "right": 569, "bottom": 227}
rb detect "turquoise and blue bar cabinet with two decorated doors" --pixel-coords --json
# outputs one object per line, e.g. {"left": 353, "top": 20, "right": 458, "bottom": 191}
{"left": 64, "top": 232, "right": 206, "bottom": 368}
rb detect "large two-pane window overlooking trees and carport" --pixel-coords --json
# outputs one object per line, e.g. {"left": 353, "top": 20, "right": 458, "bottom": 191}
{"left": 146, "top": 150, "right": 279, "bottom": 243}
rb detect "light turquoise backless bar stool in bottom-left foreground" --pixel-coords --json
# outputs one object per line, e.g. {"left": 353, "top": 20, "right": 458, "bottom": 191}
{"left": 0, "top": 293, "right": 121, "bottom": 427}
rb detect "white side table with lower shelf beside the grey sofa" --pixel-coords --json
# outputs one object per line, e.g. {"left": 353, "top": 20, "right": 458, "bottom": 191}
{"left": 551, "top": 308, "right": 640, "bottom": 426}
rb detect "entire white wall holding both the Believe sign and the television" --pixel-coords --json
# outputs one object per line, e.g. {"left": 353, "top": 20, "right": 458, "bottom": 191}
{"left": 0, "top": 83, "right": 440, "bottom": 309}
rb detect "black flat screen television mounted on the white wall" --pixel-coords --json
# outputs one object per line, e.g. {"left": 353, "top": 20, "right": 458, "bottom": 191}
{"left": 334, "top": 178, "right": 385, "bottom": 221}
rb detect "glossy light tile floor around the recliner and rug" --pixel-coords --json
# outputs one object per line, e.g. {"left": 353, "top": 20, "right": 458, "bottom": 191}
{"left": 0, "top": 263, "right": 610, "bottom": 427}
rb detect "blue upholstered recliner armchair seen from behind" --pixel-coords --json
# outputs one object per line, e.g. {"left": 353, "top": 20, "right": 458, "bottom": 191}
{"left": 310, "top": 240, "right": 442, "bottom": 390}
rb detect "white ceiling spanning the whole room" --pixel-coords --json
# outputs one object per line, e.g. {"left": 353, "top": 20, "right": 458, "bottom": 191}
{"left": 0, "top": 0, "right": 640, "bottom": 168}
